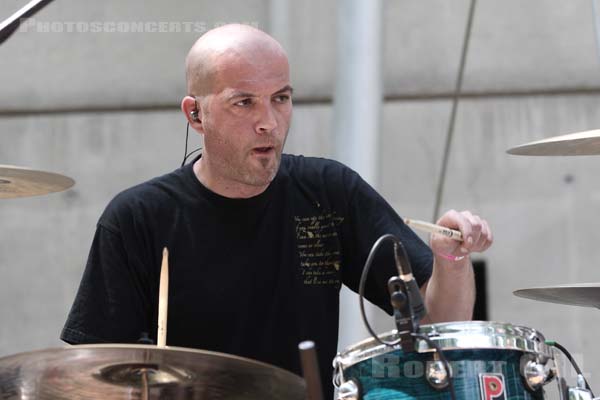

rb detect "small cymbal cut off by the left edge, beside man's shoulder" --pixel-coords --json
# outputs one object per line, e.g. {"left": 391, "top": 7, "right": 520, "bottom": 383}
{"left": 0, "top": 165, "right": 75, "bottom": 199}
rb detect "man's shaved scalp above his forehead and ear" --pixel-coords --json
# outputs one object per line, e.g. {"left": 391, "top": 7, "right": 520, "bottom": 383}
{"left": 185, "top": 24, "right": 287, "bottom": 96}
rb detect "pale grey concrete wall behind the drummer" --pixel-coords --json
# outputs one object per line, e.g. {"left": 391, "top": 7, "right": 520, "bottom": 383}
{"left": 0, "top": 0, "right": 600, "bottom": 396}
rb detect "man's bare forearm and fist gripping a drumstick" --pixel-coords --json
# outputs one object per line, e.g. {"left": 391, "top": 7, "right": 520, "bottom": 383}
{"left": 421, "top": 210, "right": 493, "bottom": 323}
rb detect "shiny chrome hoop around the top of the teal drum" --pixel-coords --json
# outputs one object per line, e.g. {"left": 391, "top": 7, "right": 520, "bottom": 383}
{"left": 334, "top": 321, "right": 552, "bottom": 368}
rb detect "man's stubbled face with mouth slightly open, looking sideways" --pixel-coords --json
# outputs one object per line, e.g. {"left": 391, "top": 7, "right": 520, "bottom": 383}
{"left": 200, "top": 55, "right": 292, "bottom": 186}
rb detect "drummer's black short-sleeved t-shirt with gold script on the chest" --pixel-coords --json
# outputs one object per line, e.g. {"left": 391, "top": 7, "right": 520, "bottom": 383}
{"left": 61, "top": 155, "right": 433, "bottom": 399}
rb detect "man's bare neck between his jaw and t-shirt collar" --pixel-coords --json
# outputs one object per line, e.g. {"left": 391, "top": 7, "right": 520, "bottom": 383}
{"left": 193, "top": 157, "right": 269, "bottom": 199}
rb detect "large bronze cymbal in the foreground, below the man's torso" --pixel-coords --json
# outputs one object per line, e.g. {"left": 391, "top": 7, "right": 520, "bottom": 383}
{"left": 0, "top": 344, "right": 306, "bottom": 400}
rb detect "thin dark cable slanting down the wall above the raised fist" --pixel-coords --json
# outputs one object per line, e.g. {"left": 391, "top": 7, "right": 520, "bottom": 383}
{"left": 433, "top": 0, "right": 477, "bottom": 222}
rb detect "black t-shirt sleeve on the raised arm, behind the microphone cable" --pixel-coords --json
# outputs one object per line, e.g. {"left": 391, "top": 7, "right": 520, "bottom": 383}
{"left": 342, "top": 170, "right": 433, "bottom": 314}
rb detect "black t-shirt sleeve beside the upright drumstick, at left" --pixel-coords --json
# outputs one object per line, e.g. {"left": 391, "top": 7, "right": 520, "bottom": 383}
{"left": 61, "top": 223, "right": 152, "bottom": 344}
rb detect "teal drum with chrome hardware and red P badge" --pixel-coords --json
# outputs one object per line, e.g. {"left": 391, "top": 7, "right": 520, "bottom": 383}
{"left": 333, "top": 321, "right": 552, "bottom": 400}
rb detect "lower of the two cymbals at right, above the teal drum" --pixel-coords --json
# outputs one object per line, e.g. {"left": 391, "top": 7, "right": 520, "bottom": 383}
{"left": 513, "top": 283, "right": 600, "bottom": 308}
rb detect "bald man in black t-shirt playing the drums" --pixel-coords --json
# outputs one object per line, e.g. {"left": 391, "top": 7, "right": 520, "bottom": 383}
{"left": 61, "top": 24, "right": 492, "bottom": 398}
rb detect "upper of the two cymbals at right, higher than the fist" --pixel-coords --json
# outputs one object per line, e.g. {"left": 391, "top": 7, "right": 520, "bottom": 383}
{"left": 507, "top": 129, "right": 600, "bottom": 156}
